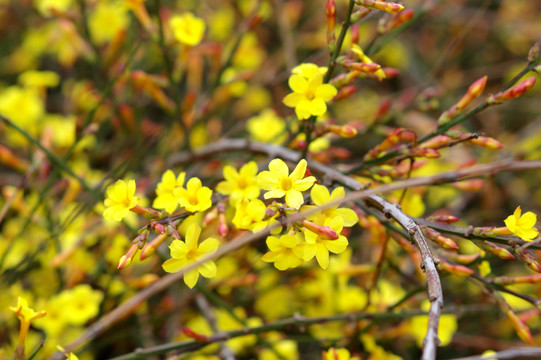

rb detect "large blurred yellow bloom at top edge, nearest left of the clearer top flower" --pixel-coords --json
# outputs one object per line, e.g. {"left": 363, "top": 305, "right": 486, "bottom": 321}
{"left": 88, "top": 1, "right": 130, "bottom": 45}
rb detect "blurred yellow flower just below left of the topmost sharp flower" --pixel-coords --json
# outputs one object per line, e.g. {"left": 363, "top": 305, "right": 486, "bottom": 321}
{"left": 246, "top": 109, "right": 287, "bottom": 144}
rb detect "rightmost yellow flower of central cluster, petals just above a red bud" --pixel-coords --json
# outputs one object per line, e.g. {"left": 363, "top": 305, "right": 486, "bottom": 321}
{"left": 302, "top": 184, "right": 359, "bottom": 227}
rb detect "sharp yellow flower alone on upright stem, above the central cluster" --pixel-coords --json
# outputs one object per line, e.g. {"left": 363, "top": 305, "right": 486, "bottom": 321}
{"left": 284, "top": 63, "right": 337, "bottom": 120}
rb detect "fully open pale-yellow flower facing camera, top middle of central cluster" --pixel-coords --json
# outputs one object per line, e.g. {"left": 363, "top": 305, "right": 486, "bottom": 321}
{"left": 257, "top": 159, "right": 316, "bottom": 209}
